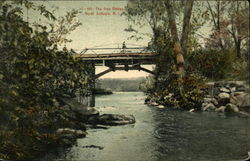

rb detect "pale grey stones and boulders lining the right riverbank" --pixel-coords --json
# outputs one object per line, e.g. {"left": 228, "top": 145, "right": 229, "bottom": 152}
{"left": 145, "top": 81, "right": 250, "bottom": 116}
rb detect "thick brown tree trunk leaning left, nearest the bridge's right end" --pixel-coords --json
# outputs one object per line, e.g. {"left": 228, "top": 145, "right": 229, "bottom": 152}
{"left": 165, "top": 0, "right": 185, "bottom": 77}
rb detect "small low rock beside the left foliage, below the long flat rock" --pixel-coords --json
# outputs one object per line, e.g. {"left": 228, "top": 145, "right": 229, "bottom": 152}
{"left": 56, "top": 128, "right": 87, "bottom": 138}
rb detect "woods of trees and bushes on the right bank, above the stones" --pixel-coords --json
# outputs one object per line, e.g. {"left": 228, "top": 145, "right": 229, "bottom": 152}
{"left": 124, "top": 0, "right": 249, "bottom": 109}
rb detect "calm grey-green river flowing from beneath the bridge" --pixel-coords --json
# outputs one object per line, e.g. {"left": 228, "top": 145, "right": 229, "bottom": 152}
{"left": 46, "top": 92, "right": 250, "bottom": 160}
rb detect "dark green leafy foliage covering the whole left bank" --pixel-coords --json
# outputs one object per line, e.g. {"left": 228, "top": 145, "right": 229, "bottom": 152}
{"left": 0, "top": 0, "right": 89, "bottom": 160}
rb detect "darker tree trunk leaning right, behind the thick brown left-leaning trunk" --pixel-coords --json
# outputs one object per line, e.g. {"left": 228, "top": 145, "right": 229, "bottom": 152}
{"left": 181, "top": 0, "right": 194, "bottom": 56}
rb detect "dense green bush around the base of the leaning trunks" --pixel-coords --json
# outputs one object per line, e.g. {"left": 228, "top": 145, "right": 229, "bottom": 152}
{"left": 147, "top": 72, "right": 206, "bottom": 110}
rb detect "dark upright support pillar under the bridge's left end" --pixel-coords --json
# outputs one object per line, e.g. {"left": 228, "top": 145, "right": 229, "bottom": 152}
{"left": 88, "top": 63, "right": 95, "bottom": 107}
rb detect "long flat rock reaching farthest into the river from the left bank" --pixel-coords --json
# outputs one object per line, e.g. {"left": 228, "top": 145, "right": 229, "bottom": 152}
{"left": 88, "top": 114, "right": 135, "bottom": 126}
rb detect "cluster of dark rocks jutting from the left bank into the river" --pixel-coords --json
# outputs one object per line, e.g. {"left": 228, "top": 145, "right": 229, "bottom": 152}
{"left": 51, "top": 97, "right": 135, "bottom": 150}
